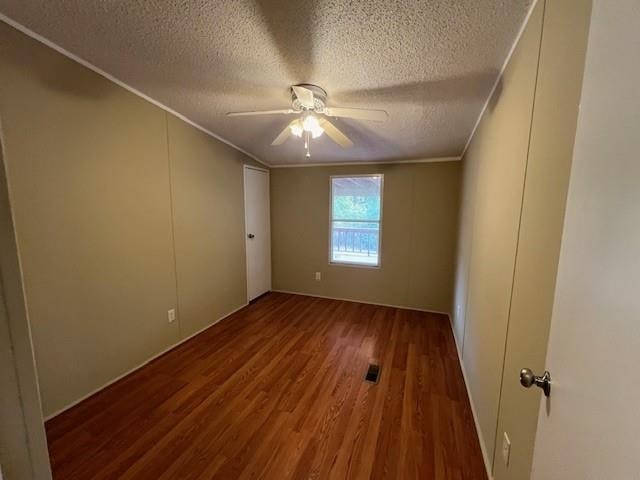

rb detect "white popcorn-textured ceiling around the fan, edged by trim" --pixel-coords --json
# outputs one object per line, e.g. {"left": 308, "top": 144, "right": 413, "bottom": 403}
{"left": 0, "top": 0, "right": 532, "bottom": 165}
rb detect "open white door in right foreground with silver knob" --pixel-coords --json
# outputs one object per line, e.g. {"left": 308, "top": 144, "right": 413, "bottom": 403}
{"left": 532, "top": 0, "right": 640, "bottom": 480}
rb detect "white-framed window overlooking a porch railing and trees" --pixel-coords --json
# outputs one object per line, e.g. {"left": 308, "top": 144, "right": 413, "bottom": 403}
{"left": 329, "top": 175, "right": 383, "bottom": 267}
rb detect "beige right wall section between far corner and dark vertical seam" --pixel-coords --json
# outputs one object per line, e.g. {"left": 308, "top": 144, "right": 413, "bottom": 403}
{"left": 453, "top": 2, "right": 542, "bottom": 464}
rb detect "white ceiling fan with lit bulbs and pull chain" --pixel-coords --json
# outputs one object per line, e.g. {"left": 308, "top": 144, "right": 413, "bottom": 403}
{"left": 227, "top": 83, "right": 389, "bottom": 158}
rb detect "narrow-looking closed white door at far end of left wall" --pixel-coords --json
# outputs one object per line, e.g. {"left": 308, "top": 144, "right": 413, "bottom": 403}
{"left": 244, "top": 166, "right": 271, "bottom": 301}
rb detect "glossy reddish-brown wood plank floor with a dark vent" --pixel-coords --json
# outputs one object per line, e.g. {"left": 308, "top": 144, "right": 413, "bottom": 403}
{"left": 46, "top": 293, "right": 486, "bottom": 480}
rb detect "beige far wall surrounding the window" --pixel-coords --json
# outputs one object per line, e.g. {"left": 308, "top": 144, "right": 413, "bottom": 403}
{"left": 271, "top": 162, "right": 460, "bottom": 312}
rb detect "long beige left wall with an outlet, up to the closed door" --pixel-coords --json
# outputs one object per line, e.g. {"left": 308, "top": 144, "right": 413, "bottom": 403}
{"left": 0, "top": 24, "right": 260, "bottom": 415}
